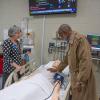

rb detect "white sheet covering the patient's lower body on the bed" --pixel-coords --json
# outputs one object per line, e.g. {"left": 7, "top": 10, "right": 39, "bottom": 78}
{"left": 0, "top": 73, "right": 53, "bottom": 100}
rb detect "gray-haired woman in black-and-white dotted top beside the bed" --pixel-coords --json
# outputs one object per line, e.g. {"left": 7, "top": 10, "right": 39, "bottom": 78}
{"left": 2, "top": 25, "right": 22, "bottom": 87}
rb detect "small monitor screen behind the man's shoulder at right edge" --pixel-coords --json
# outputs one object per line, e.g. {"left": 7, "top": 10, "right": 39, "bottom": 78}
{"left": 87, "top": 35, "right": 100, "bottom": 48}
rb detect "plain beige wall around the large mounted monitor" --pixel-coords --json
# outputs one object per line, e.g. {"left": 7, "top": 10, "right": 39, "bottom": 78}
{"left": 0, "top": 0, "right": 100, "bottom": 63}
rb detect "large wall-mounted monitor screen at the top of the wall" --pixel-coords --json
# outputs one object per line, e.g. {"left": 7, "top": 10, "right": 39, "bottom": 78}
{"left": 29, "top": 0, "right": 77, "bottom": 15}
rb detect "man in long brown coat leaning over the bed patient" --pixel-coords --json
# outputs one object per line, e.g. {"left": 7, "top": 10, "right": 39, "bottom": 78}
{"left": 48, "top": 24, "right": 96, "bottom": 100}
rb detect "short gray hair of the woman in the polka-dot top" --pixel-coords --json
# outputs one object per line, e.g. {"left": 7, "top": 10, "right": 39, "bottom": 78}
{"left": 8, "top": 25, "right": 21, "bottom": 37}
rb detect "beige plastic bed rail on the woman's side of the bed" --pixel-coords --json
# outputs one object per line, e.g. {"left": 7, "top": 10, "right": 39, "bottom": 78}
{"left": 4, "top": 60, "right": 36, "bottom": 88}
